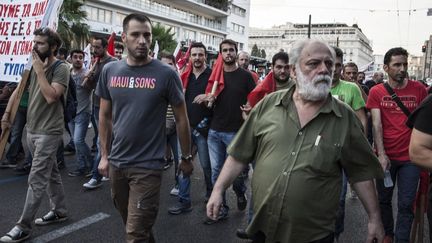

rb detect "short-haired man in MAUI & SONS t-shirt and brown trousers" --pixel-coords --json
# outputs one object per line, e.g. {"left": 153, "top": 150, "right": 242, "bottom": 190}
{"left": 96, "top": 14, "right": 193, "bottom": 242}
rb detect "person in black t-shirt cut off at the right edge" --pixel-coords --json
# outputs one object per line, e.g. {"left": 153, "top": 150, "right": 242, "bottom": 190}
{"left": 407, "top": 95, "right": 432, "bottom": 242}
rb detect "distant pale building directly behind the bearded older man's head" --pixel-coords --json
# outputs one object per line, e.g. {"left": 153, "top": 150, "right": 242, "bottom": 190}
{"left": 249, "top": 23, "right": 373, "bottom": 66}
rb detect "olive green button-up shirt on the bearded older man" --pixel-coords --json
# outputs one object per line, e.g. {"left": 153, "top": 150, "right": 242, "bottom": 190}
{"left": 228, "top": 85, "right": 383, "bottom": 242}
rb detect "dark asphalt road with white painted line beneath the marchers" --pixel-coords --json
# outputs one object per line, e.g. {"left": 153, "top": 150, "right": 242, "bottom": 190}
{"left": 0, "top": 129, "right": 429, "bottom": 243}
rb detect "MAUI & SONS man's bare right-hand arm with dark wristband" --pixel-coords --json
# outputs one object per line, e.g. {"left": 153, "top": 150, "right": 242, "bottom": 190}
{"left": 172, "top": 102, "right": 193, "bottom": 176}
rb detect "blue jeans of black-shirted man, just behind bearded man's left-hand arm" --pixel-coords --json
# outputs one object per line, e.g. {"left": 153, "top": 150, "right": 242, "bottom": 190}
{"left": 207, "top": 129, "right": 246, "bottom": 205}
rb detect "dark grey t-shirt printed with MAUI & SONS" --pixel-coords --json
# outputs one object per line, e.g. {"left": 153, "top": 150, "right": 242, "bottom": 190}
{"left": 96, "top": 60, "right": 184, "bottom": 169}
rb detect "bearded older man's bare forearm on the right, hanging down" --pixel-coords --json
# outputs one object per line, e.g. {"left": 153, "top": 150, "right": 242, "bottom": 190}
{"left": 353, "top": 180, "right": 384, "bottom": 243}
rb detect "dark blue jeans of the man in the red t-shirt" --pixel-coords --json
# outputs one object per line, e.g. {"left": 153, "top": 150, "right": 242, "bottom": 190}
{"left": 376, "top": 161, "right": 420, "bottom": 242}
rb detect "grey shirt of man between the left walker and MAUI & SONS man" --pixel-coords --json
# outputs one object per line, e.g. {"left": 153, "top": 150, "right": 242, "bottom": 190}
{"left": 71, "top": 68, "right": 91, "bottom": 114}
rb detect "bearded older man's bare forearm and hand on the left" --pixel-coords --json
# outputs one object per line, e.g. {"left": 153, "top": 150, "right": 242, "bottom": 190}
{"left": 207, "top": 155, "right": 247, "bottom": 220}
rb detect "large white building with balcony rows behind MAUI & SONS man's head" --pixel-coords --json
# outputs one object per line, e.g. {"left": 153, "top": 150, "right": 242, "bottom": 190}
{"left": 84, "top": 0, "right": 250, "bottom": 50}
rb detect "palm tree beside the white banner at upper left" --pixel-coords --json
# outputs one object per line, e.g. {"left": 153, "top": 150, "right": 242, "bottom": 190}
{"left": 57, "top": 0, "right": 90, "bottom": 49}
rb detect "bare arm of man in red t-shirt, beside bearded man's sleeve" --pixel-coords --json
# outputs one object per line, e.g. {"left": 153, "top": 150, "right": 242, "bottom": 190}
{"left": 371, "top": 108, "right": 390, "bottom": 170}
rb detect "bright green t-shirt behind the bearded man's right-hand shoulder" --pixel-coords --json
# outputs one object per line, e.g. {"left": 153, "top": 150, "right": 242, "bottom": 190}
{"left": 330, "top": 80, "right": 366, "bottom": 111}
